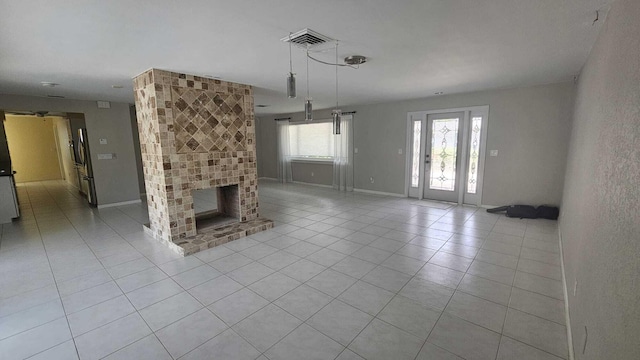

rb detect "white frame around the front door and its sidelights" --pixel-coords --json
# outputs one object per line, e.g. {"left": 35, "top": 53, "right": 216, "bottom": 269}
{"left": 404, "top": 105, "right": 489, "bottom": 206}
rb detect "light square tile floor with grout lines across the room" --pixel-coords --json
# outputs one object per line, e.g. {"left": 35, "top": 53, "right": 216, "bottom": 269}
{"left": 0, "top": 181, "right": 567, "bottom": 360}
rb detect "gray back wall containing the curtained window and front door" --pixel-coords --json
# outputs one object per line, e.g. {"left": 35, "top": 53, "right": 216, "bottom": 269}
{"left": 258, "top": 83, "right": 574, "bottom": 205}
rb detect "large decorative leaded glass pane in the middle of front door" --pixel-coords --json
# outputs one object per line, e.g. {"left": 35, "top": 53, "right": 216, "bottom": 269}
{"left": 429, "top": 118, "right": 460, "bottom": 191}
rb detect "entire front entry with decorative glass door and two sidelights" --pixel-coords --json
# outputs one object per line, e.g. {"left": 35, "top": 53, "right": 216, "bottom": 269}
{"left": 405, "top": 106, "right": 489, "bottom": 205}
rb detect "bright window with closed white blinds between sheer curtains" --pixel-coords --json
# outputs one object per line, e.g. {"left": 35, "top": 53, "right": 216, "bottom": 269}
{"left": 289, "top": 122, "right": 335, "bottom": 160}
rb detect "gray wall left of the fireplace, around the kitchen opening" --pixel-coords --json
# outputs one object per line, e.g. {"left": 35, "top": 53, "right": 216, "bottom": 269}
{"left": 0, "top": 95, "right": 140, "bottom": 205}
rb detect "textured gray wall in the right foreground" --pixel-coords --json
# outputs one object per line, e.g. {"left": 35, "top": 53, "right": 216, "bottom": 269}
{"left": 560, "top": 0, "right": 640, "bottom": 359}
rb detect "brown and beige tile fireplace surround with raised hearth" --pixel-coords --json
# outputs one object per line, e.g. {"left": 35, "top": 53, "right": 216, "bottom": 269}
{"left": 133, "top": 69, "right": 273, "bottom": 255}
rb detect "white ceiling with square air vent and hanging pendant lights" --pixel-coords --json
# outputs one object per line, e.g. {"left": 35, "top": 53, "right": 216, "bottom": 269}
{"left": 0, "top": 0, "right": 610, "bottom": 114}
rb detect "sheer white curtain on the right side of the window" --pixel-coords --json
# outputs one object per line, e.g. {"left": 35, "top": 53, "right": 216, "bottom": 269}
{"left": 333, "top": 115, "right": 353, "bottom": 191}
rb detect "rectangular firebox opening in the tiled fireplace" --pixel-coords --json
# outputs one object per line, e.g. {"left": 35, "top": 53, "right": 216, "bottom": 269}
{"left": 191, "top": 184, "right": 240, "bottom": 232}
